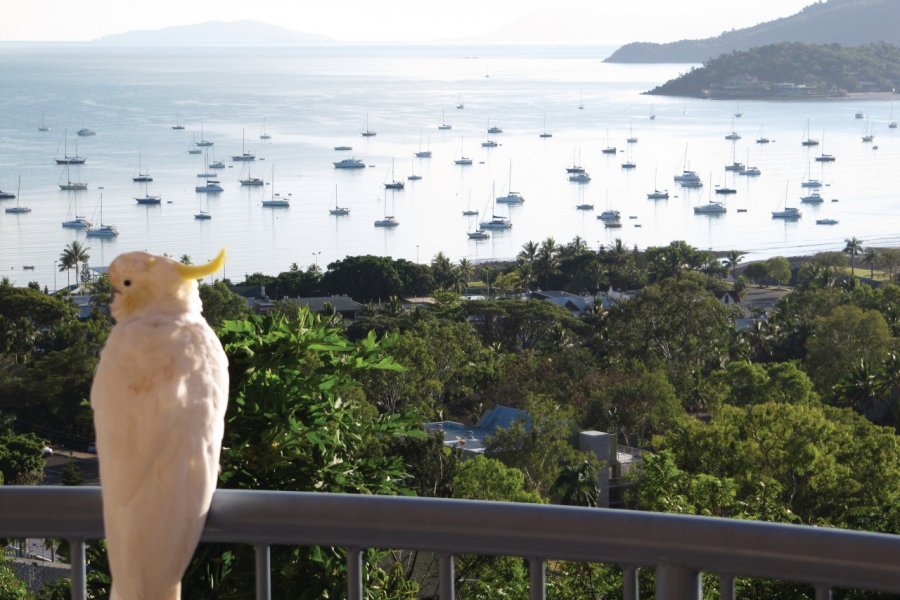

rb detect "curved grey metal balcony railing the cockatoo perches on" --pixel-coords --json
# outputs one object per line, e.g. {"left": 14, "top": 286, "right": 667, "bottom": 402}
{"left": 0, "top": 486, "right": 900, "bottom": 600}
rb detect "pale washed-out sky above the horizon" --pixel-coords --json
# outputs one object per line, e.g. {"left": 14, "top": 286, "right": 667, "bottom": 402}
{"left": 0, "top": 0, "right": 814, "bottom": 44}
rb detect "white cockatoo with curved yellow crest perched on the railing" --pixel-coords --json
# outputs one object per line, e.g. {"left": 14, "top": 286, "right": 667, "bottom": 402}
{"left": 91, "top": 249, "right": 228, "bottom": 600}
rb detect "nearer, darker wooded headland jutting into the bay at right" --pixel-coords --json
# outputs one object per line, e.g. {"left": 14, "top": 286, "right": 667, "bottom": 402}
{"left": 646, "top": 43, "right": 900, "bottom": 99}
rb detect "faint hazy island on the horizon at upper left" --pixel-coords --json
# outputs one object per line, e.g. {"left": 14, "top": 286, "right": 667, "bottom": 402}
{"left": 94, "top": 20, "right": 334, "bottom": 46}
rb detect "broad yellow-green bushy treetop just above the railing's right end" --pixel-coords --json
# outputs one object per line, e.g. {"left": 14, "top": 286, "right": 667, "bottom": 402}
{"left": 652, "top": 403, "right": 900, "bottom": 532}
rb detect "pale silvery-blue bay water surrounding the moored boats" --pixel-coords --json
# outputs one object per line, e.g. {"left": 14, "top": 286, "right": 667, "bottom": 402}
{"left": 0, "top": 45, "right": 900, "bottom": 289}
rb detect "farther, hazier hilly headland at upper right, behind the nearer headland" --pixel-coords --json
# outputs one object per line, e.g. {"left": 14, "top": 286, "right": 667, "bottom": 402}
{"left": 605, "top": 0, "right": 900, "bottom": 63}
